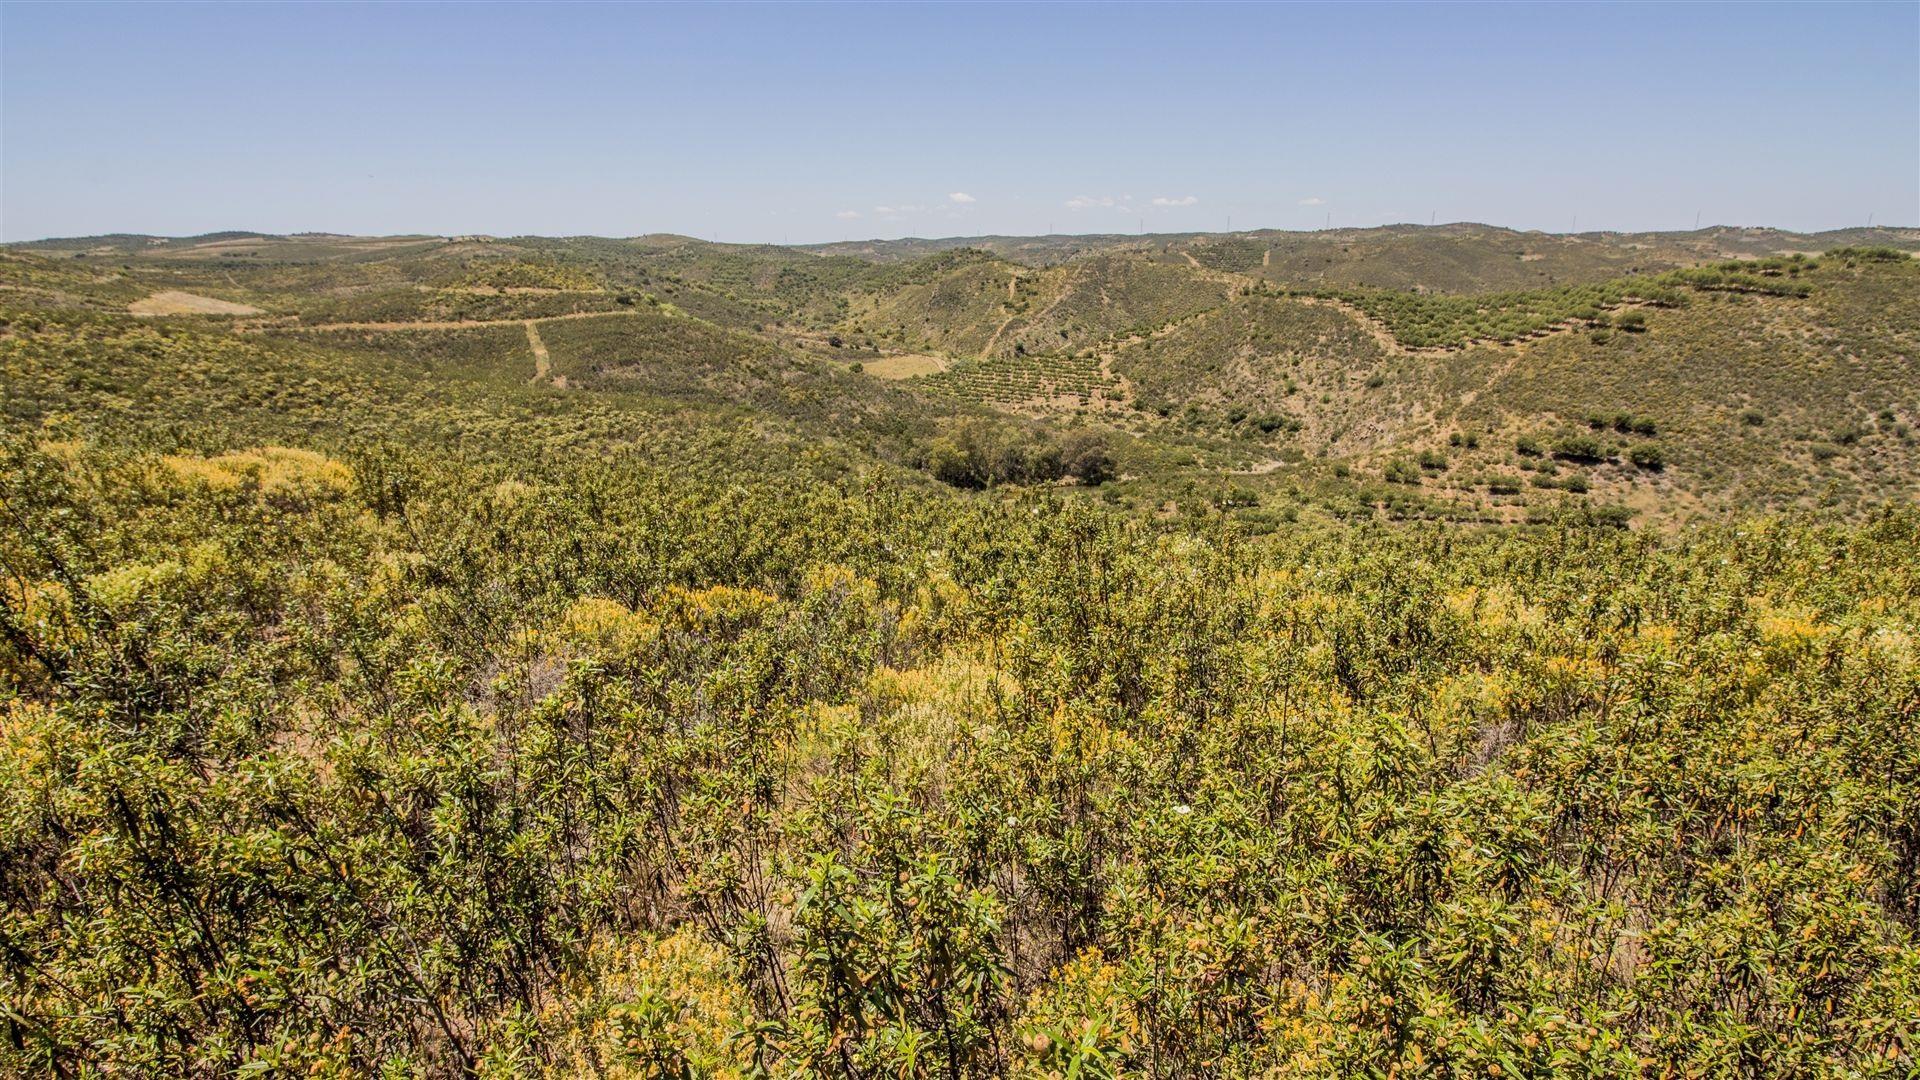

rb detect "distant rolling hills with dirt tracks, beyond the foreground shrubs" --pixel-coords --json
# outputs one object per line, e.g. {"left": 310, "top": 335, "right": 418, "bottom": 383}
{"left": 0, "top": 225, "right": 1920, "bottom": 523}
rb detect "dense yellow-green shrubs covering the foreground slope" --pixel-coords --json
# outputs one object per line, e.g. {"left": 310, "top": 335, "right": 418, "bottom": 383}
{"left": 0, "top": 438, "right": 1920, "bottom": 1076}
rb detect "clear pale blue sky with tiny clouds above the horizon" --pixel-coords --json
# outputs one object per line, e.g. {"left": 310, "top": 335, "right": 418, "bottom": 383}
{"left": 0, "top": 2, "right": 1920, "bottom": 242}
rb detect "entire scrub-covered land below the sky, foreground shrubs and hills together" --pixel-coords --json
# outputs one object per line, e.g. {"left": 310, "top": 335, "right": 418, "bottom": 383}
{"left": 0, "top": 225, "right": 1920, "bottom": 1078}
